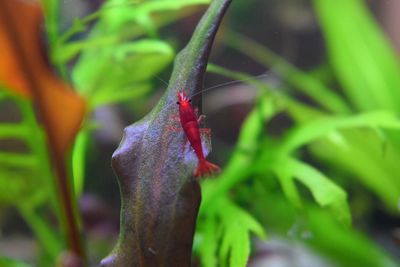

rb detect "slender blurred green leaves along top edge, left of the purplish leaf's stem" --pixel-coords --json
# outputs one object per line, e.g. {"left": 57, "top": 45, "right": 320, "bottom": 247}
{"left": 55, "top": 0, "right": 210, "bottom": 61}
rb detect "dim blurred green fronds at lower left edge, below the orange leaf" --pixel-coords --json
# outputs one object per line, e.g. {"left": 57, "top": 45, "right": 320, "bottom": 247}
{"left": 0, "top": 91, "right": 63, "bottom": 266}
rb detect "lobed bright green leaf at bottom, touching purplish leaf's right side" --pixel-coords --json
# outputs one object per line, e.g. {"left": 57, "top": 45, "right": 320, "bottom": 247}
{"left": 196, "top": 196, "right": 265, "bottom": 267}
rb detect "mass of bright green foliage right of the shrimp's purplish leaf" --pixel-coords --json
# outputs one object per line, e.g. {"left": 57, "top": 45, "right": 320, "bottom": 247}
{"left": 196, "top": 0, "right": 400, "bottom": 267}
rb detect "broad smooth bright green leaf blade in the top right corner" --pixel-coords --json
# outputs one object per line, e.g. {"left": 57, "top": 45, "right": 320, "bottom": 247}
{"left": 314, "top": 0, "right": 400, "bottom": 112}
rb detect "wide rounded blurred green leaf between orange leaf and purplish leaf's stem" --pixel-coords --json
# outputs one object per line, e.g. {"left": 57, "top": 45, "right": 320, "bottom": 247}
{"left": 73, "top": 39, "right": 174, "bottom": 108}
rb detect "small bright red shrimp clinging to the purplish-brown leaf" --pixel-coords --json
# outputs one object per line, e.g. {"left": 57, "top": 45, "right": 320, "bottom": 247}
{"left": 177, "top": 91, "right": 220, "bottom": 177}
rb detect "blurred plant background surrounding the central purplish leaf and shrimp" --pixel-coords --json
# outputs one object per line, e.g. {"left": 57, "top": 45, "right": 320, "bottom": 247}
{"left": 0, "top": 0, "right": 400, "bottom": 267}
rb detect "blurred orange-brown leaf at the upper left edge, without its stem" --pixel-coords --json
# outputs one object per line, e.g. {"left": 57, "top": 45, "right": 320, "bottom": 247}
{"left": 0, "top": 0, "right": 85, "bottom": 158}
